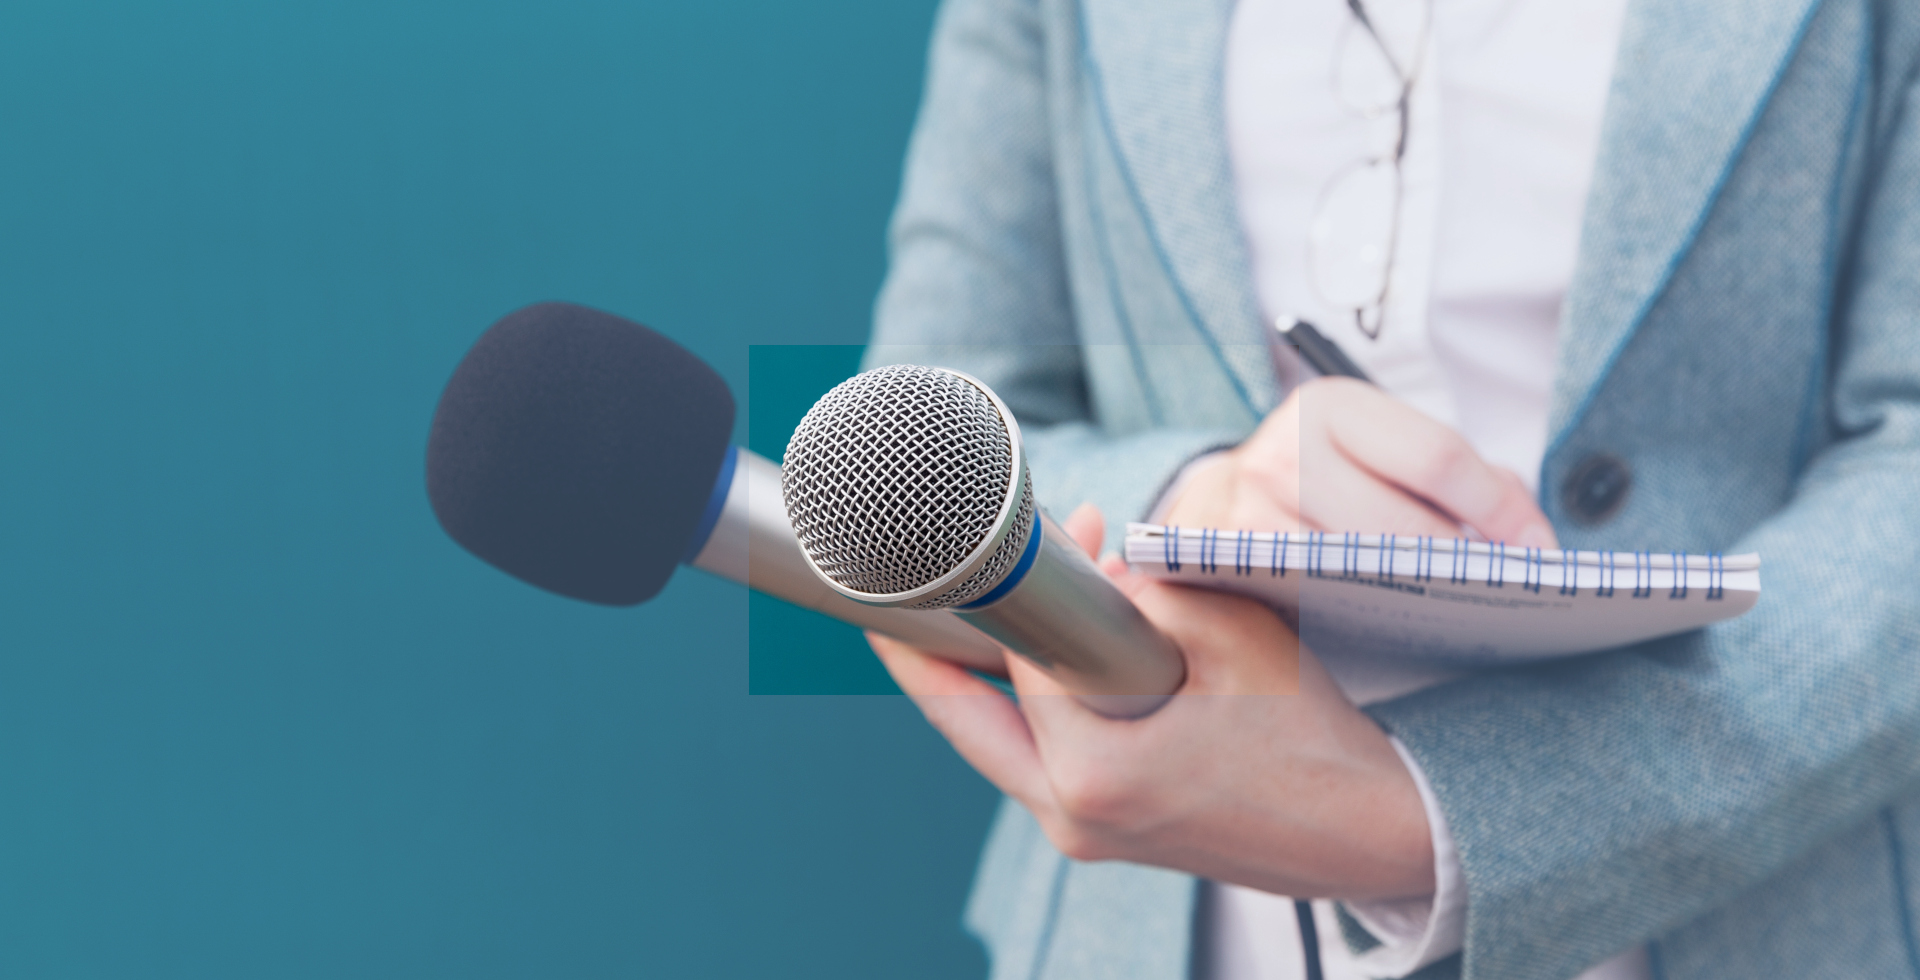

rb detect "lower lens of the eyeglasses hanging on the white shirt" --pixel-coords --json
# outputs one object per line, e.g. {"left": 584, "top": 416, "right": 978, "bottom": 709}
{"left": 1308, "top": 161, "right": 1400, "bottom": 309}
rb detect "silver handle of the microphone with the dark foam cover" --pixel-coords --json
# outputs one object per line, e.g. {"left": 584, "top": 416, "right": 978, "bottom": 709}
{"left": 691, "top": 450, "right": 1006, "bottom": 674}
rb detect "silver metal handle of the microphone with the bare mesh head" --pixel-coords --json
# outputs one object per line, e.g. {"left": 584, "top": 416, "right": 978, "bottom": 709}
{"left": 958, "top": 511, "right": 1187, "bottom": 719}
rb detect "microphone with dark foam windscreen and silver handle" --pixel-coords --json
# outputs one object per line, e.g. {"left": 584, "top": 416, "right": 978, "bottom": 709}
{"left": 426, "top": 304, "right": 1004, "bottom": 673}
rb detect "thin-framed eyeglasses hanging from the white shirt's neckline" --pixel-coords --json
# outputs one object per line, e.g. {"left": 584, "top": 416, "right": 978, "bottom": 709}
{"left": 1308, "top": 0, "right": 1432, "bottom": 340}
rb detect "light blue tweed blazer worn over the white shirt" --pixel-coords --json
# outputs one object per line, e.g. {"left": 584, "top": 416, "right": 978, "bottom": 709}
{"left": 872, "top": 0, "right": 1920, "bottom": 980}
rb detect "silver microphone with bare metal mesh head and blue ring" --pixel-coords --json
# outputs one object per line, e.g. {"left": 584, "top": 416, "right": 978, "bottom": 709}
{"left": 781, "top": 365, "right": 1187, "bottom": 717}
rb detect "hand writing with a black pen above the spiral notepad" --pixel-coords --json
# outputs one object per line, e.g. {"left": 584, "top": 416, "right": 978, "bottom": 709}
{"left": 1164, "top": 379, "right": 1555, "bottom": 548}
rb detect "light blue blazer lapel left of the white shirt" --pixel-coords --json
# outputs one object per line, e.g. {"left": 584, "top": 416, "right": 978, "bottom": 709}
{"left": 1077, "top": 0, "right": 1277, "bottom": 419}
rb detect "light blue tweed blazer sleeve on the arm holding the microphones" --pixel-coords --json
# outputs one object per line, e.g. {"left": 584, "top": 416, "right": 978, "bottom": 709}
{"left": 1369, "top": 70, "right": 1920, "bottom": 978}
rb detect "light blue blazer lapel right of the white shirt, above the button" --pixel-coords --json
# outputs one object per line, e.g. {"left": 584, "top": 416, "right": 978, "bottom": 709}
{"left": 1549, "top": 0, "right": 1820, "bottom": 440}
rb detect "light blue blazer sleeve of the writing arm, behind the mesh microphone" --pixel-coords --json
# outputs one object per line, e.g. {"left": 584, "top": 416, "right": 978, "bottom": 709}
{"left": 866, "top": 0, "right": 1244, "bottom": 544}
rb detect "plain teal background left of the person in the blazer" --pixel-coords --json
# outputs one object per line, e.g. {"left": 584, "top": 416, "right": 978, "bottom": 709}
{"left": 0, "top": 0, "right": 993, "bottom": 978}
